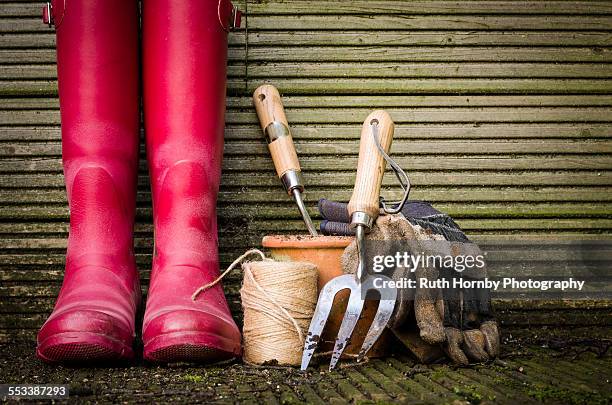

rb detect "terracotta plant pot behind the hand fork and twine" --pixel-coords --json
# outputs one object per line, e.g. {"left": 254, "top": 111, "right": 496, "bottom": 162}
{"left": 262, "top": 235, "right": 389, "bottom": 357}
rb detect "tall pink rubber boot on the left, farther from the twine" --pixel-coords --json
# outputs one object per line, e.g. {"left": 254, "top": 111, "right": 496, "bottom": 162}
{"left": 37, "top": 0, "right": 140, "bottom": 362}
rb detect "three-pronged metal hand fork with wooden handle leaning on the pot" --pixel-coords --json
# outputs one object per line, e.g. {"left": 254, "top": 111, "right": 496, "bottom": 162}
{"left": 301, "top": 110, "right": 397, "bottom": 370}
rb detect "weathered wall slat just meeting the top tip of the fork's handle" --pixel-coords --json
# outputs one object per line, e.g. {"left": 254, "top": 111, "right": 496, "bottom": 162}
{"left": 0, "top": 105, "right": 612, "bottom": 124}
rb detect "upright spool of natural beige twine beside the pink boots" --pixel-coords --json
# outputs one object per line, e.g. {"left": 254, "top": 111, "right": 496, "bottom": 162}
{"left": 240, "top": 260, "right": 318, "bottom": 365}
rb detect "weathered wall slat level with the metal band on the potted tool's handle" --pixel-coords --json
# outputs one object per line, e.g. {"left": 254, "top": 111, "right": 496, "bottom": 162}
{"left": 0, "top": 122, "right": 612, "bottom": 144}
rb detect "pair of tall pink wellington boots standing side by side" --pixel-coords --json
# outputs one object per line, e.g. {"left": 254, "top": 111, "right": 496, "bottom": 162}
{"left": 37, "top": 0, "right": 241, "bottom": 362}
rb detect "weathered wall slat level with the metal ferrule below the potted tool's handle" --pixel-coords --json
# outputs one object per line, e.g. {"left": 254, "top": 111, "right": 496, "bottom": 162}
{"left": 0, "top": 171, "right": 612, "bottom": 192}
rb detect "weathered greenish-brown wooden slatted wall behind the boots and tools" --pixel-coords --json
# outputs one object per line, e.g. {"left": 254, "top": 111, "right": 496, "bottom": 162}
{"left": 0, "top": 0, "right": 612, "bottom": 340}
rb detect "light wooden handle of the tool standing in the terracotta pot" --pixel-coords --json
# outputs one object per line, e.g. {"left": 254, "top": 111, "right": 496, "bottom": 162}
{"left": 253, "top": 84, "right": 301, "bottom": 179}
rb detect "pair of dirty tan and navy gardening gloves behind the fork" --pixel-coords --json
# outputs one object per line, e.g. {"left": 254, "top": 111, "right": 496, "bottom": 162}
{"left": 328, "top": 200, "right": 499, "bottom": 365}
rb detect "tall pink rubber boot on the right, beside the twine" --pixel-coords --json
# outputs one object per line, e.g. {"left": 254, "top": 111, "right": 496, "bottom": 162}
{"left": 142, "top": 0, "right": 240, "bottom": 362}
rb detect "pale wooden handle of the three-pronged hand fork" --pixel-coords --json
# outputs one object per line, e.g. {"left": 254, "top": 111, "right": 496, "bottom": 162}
{"left": 348, "top": 110, "right": 395, "bottom": 219}
